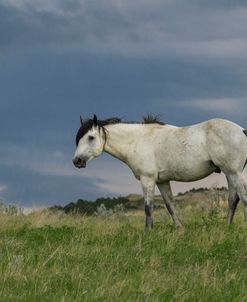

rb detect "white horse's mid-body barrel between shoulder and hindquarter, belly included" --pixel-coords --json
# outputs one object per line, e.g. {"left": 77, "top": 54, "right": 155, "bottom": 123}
{"left": 155, "top": 123, "right": 215, "bottom": 182}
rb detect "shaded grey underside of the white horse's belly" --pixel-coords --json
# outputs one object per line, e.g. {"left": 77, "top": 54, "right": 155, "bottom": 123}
{"left": 158, "top": 162, "right": 215, "bottom": 182}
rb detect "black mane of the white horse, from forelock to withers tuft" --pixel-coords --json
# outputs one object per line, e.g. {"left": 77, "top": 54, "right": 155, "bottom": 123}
{"left": 76, "top": 114, "right": 165, "bottom": 146}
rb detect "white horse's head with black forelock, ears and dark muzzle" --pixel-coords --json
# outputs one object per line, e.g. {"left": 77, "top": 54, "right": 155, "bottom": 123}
{"left": 73, "top": 115, "right": 106, "bottom": 168}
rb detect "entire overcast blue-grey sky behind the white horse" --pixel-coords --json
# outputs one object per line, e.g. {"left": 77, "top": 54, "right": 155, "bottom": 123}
{"left": 0, "top": 0, "right": 247, "bottom": 206}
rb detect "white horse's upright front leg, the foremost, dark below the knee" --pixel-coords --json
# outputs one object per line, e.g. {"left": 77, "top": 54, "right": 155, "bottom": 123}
{"left": 141, "top": 176, "right": 155, "bottom": 230}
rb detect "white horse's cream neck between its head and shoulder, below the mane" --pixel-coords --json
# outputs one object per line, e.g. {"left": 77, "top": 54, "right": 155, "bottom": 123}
{"left": 104, "top": 124, "right": 144, "bottom": 162}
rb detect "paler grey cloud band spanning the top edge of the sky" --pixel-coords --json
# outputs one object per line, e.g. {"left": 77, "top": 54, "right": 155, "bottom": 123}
{"left": 0, "top": 0, "right": 247, "bottom": 60}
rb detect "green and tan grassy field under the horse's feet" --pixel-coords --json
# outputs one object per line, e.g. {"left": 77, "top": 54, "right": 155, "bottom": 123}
{"left": 0, "top": 204, "right": 247, "bottom": 302}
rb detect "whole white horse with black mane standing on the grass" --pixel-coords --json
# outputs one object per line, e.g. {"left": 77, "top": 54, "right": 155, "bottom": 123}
{"left": 73, "top": 115, "right": 247, "bottom": 228}
